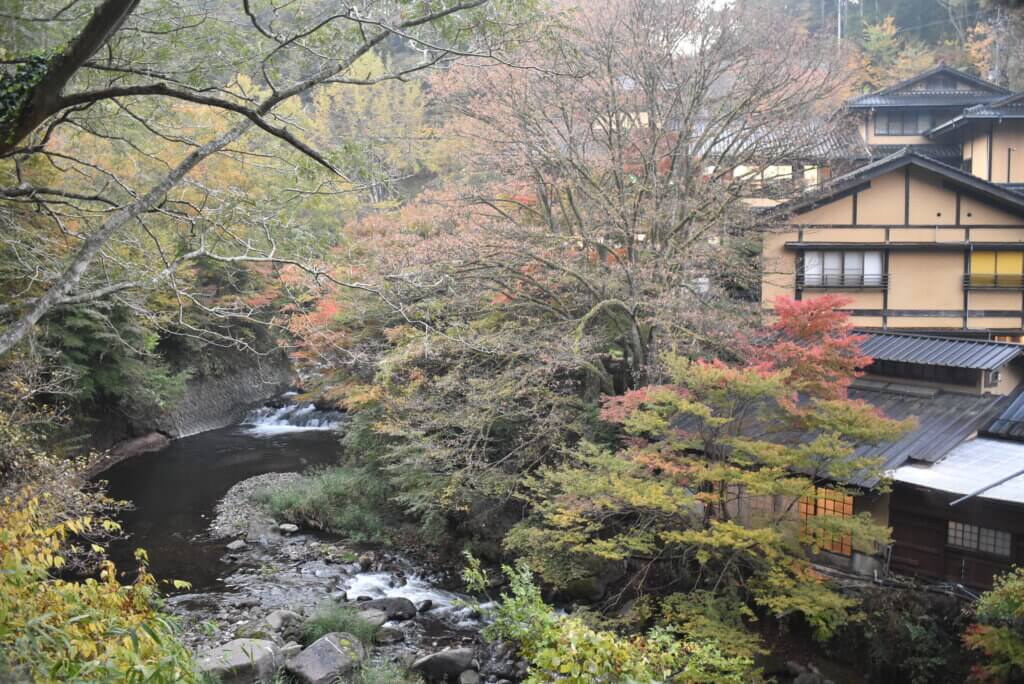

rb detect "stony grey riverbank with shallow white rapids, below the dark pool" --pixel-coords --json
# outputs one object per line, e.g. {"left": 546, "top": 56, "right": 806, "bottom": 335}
{"left": 166, "top": 473, "right": 525, "bottom": 683}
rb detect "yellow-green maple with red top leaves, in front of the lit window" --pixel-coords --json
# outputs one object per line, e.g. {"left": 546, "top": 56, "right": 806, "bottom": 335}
{"left": 506, "top": 302, "right": 906, "bottom": 653}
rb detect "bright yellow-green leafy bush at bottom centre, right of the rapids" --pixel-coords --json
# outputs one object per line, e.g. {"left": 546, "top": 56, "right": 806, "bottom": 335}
{"left": 465, "top": 557, "right": 759, "bottom": 684}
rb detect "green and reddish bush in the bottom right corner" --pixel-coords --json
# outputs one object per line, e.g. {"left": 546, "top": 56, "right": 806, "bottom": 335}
{"left": 964, "top": 567, "right": 1024, "bottom": 682}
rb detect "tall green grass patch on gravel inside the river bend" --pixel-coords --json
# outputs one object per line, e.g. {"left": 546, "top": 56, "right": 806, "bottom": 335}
{"left": 256, "top": 466, "right": 388, "bottom": 542}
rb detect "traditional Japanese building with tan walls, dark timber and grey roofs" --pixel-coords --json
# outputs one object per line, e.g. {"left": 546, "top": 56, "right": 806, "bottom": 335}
{"left": 762, "top": 66, "right": 1024, "bottom": 588}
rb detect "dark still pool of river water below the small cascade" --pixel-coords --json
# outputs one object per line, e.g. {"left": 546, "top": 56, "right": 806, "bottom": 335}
{"left": 99, "top": 427, "right": 339, "bottom": 590}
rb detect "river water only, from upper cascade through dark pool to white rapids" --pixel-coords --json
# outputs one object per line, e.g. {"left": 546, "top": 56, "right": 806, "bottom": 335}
{"left": 100, "top": 397, "right": 476, "bottom": 630}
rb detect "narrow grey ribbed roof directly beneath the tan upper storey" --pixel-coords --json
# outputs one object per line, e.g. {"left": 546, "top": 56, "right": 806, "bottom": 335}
{"left": 860, "top": 333, "right": 1024, "bottom": 371}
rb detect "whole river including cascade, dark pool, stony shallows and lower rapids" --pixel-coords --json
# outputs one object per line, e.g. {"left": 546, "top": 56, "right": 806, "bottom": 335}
{"left": 99, "top": 403, "right": 495, "bottom": 681}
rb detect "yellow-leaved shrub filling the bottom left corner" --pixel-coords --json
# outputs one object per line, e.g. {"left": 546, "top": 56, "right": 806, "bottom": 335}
{"left": 0, "top": 494, "right": 196, "bottom": 682}
